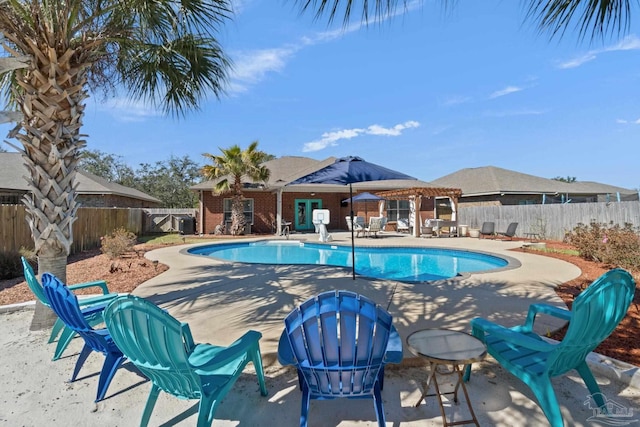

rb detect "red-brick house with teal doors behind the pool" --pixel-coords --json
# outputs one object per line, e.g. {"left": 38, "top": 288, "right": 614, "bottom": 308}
{"left": 191, "top": 156, "right": 459, "bottom": 234}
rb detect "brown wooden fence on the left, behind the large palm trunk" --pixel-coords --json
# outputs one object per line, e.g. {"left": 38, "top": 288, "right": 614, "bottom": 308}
{"left": 0, "top": 205, "right": 143, "bottom": 253}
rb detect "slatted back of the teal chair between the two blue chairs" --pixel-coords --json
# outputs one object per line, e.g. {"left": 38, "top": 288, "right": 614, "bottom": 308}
{"left": 104, "top": 295, "right": 202, "bottom": 399}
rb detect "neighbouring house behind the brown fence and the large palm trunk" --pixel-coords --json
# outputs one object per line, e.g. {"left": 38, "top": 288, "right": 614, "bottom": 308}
{"left": 0, "top": 153, "right": 162, "bottom": 208}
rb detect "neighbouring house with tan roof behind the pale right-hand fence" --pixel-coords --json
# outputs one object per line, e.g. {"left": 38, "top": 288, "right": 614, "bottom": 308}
{"left": 431, "top": 166, "right": 638, "bottom": 207}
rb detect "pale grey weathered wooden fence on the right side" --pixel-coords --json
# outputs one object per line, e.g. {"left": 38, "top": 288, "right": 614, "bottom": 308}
{"left": 458, "top": 201, "right": 640, "bottom": 240}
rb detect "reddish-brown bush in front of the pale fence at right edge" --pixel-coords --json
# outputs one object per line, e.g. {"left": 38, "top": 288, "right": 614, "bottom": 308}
{"left": 565, "top": 222, "right": 640, "bottom": 271}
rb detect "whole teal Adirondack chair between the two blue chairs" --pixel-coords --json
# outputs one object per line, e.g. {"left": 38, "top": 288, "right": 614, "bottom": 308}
{"left": 104, "top": 295, "right": 267, "bottom": 427}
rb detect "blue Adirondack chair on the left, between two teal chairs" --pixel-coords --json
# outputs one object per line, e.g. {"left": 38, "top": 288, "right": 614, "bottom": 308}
{"left": 42, "top": 273, "right": 125, "bottom": 402}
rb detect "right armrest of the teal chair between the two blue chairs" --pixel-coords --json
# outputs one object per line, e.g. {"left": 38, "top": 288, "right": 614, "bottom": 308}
{"left": 189, "top": 331, "right": 262, "bottom": 375}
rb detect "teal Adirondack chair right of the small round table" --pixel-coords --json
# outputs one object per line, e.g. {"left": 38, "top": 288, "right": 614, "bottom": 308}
{"left": 466, "top": 269, "right": 636, "bottom": 427}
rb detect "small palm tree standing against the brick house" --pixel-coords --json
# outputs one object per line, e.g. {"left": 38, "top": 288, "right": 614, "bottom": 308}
{"left": 202, "top": 141, "right": 272, "bottom": 236}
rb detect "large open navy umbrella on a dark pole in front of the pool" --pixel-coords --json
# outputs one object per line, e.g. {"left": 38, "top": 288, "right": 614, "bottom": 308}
{"left": 287, "top": 156, "right": 416, "bottom": 280}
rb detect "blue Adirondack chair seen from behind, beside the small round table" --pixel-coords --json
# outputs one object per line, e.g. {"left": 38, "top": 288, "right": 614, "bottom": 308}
{"left": 278, "top": 291, "right": 402, "bottom": 427}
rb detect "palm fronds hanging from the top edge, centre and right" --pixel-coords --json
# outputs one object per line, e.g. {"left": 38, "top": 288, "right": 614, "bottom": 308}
{"left": 296, "top": 0, "right": 637, "bottom": 38}
